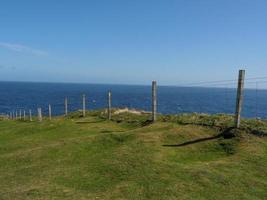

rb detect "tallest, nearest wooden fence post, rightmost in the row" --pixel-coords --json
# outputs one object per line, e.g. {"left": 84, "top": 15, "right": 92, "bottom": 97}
{"left": 235, "top": 70, "right": 245, "bottom": 128}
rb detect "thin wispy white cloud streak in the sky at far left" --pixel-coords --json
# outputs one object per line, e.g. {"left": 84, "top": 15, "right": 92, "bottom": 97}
{"left": 0, "top": 42, "right": 47, "bottom": 56}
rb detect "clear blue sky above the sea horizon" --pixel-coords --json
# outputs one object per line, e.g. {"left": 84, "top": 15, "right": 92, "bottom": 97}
{"left": 0, "top": 0, "right": 267, "bottom": 85}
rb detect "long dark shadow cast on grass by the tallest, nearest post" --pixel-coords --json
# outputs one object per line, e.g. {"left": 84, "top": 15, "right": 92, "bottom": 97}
{"left": 162, "top": 127, "right": 235, "bottom": 147}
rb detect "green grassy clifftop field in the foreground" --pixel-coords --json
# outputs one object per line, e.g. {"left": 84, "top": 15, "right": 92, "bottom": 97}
{"left": 0, "top": 113, "right": 267, "bottom": 200}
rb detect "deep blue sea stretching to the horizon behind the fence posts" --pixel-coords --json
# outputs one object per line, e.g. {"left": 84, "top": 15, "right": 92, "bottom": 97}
{"left": 0, "top": 82, "right": 267, "bottom": 118}
